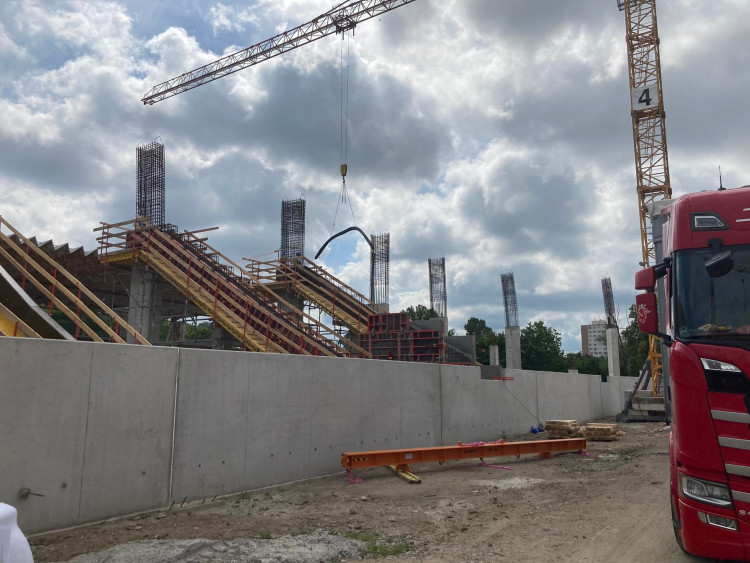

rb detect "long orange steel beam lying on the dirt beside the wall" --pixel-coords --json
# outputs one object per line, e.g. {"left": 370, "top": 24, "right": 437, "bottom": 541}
{"left": 341, "top": 438, "right": 586, "bottom": 471}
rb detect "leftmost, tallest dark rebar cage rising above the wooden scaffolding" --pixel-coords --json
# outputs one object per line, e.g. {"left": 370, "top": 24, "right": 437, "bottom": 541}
{"left": 135, "top": 141, "right": 166, "bottom": 227}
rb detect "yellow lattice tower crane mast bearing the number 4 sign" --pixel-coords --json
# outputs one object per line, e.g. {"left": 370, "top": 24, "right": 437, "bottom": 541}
{"left": 617, "top": 0, "right": 672, "bottom": 395}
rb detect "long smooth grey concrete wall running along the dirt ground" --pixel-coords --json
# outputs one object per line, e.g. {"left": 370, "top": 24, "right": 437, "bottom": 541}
{"left": 0, "top": 338, "right": 633, "bottom": 533}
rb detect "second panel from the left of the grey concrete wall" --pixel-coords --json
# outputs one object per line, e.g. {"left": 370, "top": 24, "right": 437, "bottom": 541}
{"left": 79, "top": 344, "right": 178, "bottom": 522}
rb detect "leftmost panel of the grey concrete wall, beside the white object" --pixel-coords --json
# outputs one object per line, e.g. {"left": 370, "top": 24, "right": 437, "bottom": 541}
{"left": 0, "top": 338, "right": 95, "bottom": 534}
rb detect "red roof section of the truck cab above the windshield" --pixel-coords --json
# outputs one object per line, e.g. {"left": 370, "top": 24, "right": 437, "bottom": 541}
{"left": 661, "top": 186, "right": 750, "bottom": 256}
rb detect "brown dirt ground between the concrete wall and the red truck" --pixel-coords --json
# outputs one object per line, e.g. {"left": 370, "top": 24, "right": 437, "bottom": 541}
{"left": 30, "top": 423, "right": 712, "bottom": 563}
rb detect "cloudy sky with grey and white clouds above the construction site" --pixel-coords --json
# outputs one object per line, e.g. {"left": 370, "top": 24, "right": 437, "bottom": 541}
{"left": 0, "top": 0, "right": 750, "bottom": 351}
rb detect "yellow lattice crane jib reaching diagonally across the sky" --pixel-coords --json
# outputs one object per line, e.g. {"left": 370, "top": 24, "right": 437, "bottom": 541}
{"left": 141, "top": 0, "right": 415, "bottom": 105}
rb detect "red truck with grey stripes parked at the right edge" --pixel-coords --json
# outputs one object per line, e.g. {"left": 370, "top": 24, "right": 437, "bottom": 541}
{"left": 635, "top": 186, "right": 750, "bottom": 561}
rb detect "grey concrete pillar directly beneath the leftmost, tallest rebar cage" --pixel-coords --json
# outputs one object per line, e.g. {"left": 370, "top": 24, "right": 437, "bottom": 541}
{"left": 128, "top": 262, "right": 162, "bottom": 344}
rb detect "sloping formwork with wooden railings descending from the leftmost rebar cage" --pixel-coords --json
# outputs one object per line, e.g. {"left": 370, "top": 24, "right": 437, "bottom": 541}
{"left": 96, "top": 217, "right": 369, "bottom": 357}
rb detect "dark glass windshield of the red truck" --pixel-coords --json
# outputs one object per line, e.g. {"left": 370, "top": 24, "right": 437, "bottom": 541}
{"left": 673, "top": 245, "right": 750, "bottom": 339}
